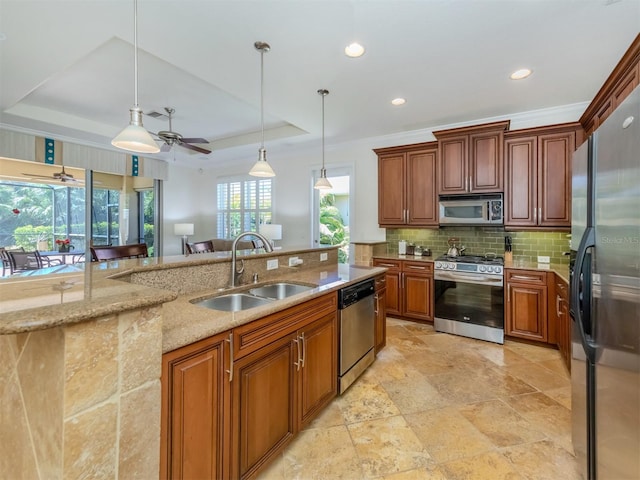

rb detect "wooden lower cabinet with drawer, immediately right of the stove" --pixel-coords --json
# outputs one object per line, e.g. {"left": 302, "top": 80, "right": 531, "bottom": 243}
{"left": 504, "top": 269, "right": 548, "bottom": 342}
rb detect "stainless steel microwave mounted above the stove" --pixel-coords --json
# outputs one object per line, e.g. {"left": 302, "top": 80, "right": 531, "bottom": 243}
{"left": 439, "top": 193, "right": 504, "bottom": 225}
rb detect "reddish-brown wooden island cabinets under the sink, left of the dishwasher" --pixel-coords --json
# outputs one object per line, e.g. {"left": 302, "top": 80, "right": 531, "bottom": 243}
{"left": 160, "top": 292, "right": 338, "bottom": 480}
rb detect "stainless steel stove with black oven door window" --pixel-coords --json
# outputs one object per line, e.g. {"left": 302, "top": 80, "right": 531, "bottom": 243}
{"left": 434, "top": 255, "right": 504, "bottom": 343}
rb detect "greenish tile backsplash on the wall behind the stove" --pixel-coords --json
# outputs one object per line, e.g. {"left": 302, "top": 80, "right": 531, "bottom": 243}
{"left": 387, "top": 227, "right": 570, "bottom": 265}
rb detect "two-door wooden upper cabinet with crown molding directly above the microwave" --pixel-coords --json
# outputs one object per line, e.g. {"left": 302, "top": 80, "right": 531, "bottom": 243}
{"left": 433, "top": 121, "right": 509, "bottom": 195}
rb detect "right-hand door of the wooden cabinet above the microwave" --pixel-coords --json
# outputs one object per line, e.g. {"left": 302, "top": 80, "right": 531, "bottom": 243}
{"left": 468, "top": 132, "right": 503, "bottom": 193}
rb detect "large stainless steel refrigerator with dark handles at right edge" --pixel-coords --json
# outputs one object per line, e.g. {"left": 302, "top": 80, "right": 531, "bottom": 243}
{"left": 570, "top": 87, "right": 640, "bottom": 480}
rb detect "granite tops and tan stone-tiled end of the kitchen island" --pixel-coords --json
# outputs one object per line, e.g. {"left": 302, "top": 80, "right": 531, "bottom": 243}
{"left": 0, "top": 247, "right": 383, "bottom": 478}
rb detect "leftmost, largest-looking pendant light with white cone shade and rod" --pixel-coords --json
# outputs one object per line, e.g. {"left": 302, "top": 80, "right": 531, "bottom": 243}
{"left": 111, "top": 0, "right": 160, "bottom": 153}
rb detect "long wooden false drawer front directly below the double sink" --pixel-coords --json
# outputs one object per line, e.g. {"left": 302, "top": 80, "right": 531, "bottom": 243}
{"left": 233, "top": 292, "right": 338, "bottom": 359}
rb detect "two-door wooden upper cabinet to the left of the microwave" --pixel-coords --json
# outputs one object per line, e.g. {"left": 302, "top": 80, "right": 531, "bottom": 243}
{"left": 375, "top": 142, "right": 438, "bottom": 227}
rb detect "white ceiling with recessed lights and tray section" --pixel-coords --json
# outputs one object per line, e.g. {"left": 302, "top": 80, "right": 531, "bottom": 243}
{"left": 0, "top": 0, "right": 640, "bottom": 168}
